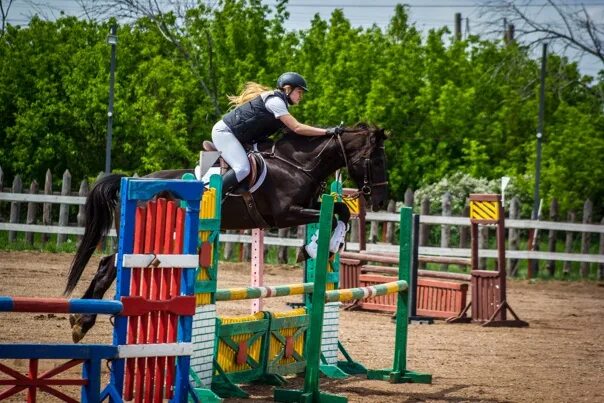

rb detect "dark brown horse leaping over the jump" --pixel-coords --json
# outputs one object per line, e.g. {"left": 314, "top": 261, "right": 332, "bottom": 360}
{"left": 64, "top": 124, "right": 388, "bottom": 342}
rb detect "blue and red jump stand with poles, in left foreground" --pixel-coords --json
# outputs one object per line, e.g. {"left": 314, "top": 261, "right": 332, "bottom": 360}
{"left": 0, "top": 178, "right": 203, "bottom": 403}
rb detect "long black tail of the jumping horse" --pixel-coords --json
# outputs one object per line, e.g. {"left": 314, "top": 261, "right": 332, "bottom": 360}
{"left": 64, "top": 174, "right": 125, "bottom": 295}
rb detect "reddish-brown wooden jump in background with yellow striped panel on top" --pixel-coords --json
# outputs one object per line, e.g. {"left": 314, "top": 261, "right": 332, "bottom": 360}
{"left": 340, "top": 194, "right": 528, "bottom": 327}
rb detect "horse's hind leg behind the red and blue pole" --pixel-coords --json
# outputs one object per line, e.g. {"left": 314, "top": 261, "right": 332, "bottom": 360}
{"left": 69, "top": 254, "right": 117, "bottom": 343}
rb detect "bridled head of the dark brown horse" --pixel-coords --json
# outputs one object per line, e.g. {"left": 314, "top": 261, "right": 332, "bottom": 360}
{"left": 339, "top": 124, "right": 388, "bottom": 211}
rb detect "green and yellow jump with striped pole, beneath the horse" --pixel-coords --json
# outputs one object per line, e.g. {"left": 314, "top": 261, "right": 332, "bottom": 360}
{"left": 192, "top": 187, "right": 431, "bottom": 401}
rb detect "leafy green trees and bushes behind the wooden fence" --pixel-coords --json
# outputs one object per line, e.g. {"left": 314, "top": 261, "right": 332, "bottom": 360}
{"left": 0, "top": 0, "right": 604, "bottom": 216}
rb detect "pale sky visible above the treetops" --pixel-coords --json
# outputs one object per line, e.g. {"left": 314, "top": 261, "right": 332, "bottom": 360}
{"left": 0, "top": 0, "right": 604, "bottom": 76}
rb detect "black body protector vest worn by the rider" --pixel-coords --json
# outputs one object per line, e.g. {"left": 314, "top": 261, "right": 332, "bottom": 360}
{"left": 222, "top": 91, "right": 289, "bottom": 144}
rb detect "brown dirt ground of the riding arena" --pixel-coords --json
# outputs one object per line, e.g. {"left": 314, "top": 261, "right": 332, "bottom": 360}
{"left": 0, "top": 252, "right": 604, "bottom": 402}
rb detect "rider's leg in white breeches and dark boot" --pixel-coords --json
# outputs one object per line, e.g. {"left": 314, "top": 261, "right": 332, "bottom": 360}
{"left": 212, "top": 121, "right": 250, "bottom": 196}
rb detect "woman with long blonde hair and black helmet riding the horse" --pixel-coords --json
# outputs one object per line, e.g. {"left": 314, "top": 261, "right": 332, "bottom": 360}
{"left": 212, "top": 72, "right": 340, "bottom": 197}
